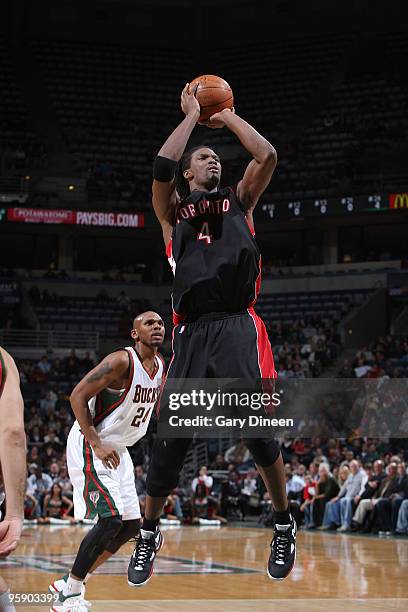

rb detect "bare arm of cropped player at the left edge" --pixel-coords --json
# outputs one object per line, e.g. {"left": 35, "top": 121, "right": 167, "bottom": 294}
{"left": 0, "top": 349, "right": 27, "bottom": 556}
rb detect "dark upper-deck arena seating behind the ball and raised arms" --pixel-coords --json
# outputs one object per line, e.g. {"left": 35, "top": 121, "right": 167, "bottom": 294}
{"left": 0, "top": 33, "right": 408, "bottom": 207}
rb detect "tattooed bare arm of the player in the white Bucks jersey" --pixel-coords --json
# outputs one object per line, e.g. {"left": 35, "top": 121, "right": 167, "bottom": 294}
{"left": 70, "top": 350, "right": 129, "bottom": 469}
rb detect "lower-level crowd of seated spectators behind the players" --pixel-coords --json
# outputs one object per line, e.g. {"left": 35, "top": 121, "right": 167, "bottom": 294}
{"left": 1, "top": 328, "right": 408, "bottom": 534}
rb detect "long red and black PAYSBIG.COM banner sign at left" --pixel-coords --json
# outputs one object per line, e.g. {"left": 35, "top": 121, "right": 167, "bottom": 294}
{"left": 7, "top": 208, "right": 144, "bottom": 228}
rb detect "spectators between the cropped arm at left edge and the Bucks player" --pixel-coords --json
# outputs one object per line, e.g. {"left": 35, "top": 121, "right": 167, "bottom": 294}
{"left": 17, "top": 351, "right": 91, "bottom": 522}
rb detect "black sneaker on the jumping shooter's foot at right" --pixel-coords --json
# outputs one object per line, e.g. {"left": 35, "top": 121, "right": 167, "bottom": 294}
{"left": 268, "top": 518, "right": 296, "bottom": 580}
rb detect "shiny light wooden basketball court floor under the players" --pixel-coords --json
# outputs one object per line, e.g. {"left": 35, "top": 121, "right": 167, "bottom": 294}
{"left": 0, "top": 526, "right": 408, "bottom": 612}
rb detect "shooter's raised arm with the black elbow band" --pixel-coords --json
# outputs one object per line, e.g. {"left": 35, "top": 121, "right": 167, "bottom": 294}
{"left": 152, "top": 83, "right": 200, "bottom": 246}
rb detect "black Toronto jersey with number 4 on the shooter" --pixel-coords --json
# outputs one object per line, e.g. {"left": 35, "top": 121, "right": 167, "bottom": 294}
{"left": 167, "top": 187, "right": 261, "bottom": 323}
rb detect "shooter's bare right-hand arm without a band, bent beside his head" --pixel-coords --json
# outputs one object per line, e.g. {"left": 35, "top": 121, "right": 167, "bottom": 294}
{"left": 207, "top": 109, "right": 278, "bottom": 212}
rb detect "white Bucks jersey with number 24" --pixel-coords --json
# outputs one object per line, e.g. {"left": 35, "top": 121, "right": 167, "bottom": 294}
{"left": 89, "top": 346, "right": 164, "bottom": 448}
